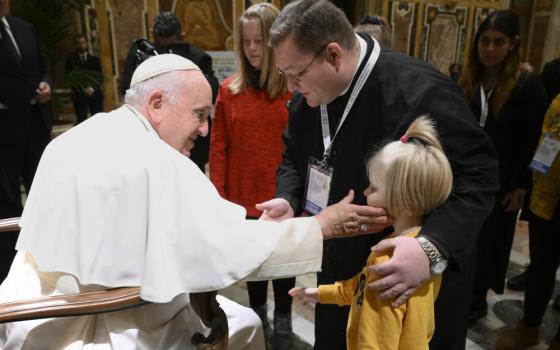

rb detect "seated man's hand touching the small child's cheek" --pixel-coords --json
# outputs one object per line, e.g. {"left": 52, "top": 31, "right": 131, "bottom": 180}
{"left": 315, "top": 190, "right": 393, "bottom": 239}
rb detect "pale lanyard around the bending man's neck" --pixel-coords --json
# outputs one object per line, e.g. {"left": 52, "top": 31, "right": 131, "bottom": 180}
{"left": 321, "top": 39, "right": 381, "bottom": 161}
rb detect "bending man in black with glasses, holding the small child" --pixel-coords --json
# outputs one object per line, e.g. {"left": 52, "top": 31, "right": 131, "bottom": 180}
{"left": 257, "top": 0, "right": 498, "bottom": 350}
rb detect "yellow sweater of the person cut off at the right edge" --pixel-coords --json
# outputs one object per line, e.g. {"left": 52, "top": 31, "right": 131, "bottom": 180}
{"left": 531, "top": 94, "right": 560, "bottom": 220}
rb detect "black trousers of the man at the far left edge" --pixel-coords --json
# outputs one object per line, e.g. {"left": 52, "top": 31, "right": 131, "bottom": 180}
{"left": 0, "top": 106, "right": 50, "bottom": 281}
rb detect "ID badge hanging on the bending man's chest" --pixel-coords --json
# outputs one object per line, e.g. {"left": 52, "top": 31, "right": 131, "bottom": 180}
{"left": 304, "top": 158, "right": 333, "bottom": 215}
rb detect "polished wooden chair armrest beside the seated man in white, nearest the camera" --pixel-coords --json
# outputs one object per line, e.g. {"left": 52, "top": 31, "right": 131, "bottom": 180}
{"left": 0, "top": 287, "right": 149, "bottom": 323}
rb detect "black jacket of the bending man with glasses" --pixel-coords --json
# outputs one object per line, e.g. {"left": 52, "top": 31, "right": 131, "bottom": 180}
{"left": 276, "top": 36, "right": 498, "bottom": 283}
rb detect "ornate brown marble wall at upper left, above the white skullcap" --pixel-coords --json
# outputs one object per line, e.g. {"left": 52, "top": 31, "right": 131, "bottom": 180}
{"left": 79, "top": 0, "right": 281, "bottom": 110}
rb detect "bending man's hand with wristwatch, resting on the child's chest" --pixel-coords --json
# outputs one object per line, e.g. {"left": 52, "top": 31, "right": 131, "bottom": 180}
{"left": 368, "top": 237, "right": 431, "bottom": 307}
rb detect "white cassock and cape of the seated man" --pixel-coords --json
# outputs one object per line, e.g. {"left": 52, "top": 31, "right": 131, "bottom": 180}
{"left": 0, "top": 105, "right": 322, "bottom": 349}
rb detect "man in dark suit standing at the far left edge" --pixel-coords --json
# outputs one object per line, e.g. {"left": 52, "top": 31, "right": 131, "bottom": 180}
{"left": 0, "top": 0, "right": 52, "bottom": 281}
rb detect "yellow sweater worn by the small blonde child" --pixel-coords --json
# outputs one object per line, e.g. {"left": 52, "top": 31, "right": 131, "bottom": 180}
{"left": 319, "top": 229, "right": 441, "bottom": 350}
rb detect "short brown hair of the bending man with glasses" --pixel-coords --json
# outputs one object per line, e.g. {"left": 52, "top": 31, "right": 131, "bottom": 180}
{"left": 268, "top": 0, "right": 356, "bottom": 54}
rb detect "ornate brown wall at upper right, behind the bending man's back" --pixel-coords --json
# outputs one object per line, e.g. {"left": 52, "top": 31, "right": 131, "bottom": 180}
{"left": 356, "top": 0, "right": 560, "bottom": 73}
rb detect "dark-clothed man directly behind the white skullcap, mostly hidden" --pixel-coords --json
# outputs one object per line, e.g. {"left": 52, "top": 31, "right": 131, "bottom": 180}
{"left": 119, "top": 12, "right": 220, "bottom": 172}
